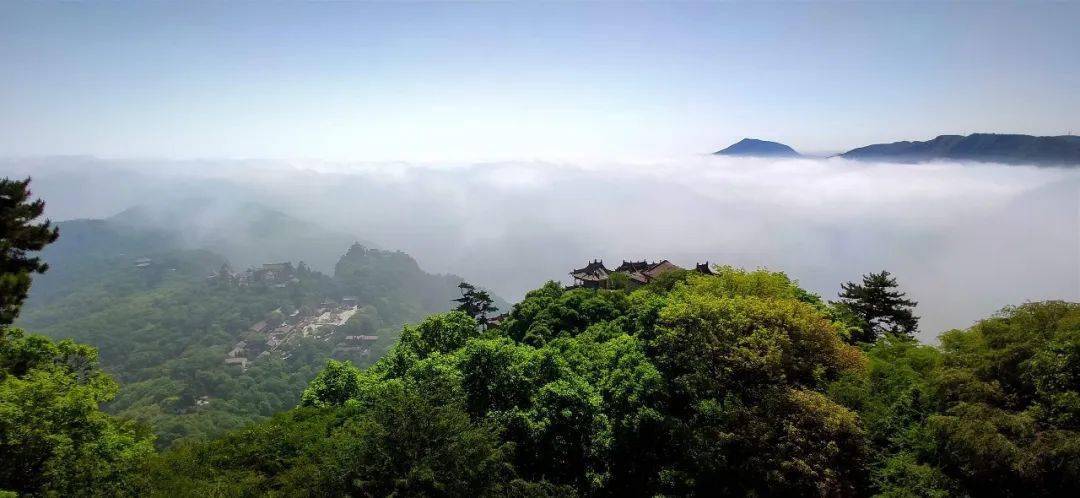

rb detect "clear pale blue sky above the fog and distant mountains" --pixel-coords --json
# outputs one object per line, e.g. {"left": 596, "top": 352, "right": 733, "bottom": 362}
{"left": 0, "top": 1, "right": 1080, "bottom": 160}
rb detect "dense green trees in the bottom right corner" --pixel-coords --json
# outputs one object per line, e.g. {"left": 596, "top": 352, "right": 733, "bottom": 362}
{"left": 928, "top": 301, "right": 1080, "bottom": 496}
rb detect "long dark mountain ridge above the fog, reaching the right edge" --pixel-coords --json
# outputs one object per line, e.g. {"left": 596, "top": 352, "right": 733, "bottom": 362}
{"left": 839, "top": 133, "right": 1080, "bottom": 165}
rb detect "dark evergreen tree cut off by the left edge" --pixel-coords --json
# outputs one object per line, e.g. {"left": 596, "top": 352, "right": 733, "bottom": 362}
{"left": 0, "top": 178, "right": 59, "bottom": 325}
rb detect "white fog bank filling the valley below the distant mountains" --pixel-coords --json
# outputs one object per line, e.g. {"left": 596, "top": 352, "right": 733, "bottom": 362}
{"left": 0, "top": 157, "right": 1080, "bottom": 341}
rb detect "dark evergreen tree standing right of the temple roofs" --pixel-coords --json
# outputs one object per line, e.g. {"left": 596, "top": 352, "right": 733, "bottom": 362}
{"left": 839, "top": 270, "right": 919, "bottom": 344}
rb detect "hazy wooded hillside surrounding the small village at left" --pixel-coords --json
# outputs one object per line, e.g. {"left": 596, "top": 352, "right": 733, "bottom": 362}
{"left": 19, "top": 214, "right": 477, "bottom": 446}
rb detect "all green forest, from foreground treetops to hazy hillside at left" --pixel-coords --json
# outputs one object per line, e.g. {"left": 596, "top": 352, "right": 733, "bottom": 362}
{"left": 0, "top": 180, "right": 1080, "bottom": 497}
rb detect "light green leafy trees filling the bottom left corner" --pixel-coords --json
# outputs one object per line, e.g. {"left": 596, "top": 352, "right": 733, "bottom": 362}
{"left": 0, "top": 328, "right": 153, "bottom": 496}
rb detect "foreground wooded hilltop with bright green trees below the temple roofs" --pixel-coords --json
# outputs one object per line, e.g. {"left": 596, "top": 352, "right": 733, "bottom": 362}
{"left": 132, "top": 272, "right": 1080, "bottom": 497}
